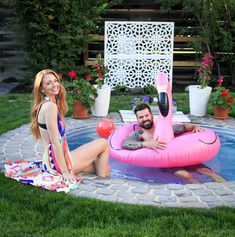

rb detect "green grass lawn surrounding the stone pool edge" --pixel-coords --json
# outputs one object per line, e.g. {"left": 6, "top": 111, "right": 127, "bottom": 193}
{"left": 0, "top": 93, "right": 235, "bottom": 237}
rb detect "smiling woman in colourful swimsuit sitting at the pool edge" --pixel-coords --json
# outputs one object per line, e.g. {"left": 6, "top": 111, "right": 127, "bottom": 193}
{"left": 31, "top": 69, "right": 110, "bottom": 182}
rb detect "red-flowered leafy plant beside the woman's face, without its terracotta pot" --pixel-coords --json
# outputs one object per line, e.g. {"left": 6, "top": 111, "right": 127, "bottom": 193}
{"left": 62, "top": 70, "right": 97, "bottom": 108}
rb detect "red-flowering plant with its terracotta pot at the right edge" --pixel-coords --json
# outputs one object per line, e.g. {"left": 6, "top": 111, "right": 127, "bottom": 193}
{"left": 209, "top": 76, "right": 233, "bottom": 119}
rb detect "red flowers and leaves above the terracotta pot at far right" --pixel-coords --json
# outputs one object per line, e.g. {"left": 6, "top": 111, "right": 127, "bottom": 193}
{"left": 209, "top": 76, "right": 233, "bottom": 109}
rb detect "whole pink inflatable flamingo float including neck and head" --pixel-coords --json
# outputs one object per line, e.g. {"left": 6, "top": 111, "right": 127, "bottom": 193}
{"left": 109, "top": 72, "right": 220, "bottom": 168}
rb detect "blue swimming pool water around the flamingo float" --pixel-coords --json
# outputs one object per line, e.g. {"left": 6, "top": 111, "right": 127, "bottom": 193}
{"left": 67, "top": 125, "right": 235, "bottom": 184}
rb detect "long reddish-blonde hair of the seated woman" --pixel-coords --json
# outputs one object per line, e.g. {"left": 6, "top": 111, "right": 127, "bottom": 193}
{"left": 31, "top": 69, "right": 68, "bottom": 140}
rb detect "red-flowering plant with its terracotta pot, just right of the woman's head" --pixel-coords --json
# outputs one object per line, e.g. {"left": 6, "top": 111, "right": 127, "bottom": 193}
{"left": 63, "top": 70, "right": 97, "bottom": 118}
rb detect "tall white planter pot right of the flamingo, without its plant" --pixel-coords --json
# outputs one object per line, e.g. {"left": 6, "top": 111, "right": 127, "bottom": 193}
{"left": 189, "top": 85, "right": 212, "bottom": 116}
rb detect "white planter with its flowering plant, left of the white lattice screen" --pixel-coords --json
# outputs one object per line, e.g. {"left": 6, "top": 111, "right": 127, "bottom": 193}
{"left": 90, "top": 60, "right": 111, "bottom": 117}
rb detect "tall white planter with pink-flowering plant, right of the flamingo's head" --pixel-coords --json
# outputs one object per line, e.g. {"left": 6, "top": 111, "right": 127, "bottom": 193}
{"left": 189, "top": 53, "right": 214, "bottom": 116}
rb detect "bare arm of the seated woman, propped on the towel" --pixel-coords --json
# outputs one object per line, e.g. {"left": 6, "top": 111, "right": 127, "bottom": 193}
{"left": 44, "top": 102, "right": 75, "bottom": 181}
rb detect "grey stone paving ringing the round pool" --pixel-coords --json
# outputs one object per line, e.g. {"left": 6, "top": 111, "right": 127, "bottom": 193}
{"left": 0, "top": 113, "right": 235, "bottom": 208}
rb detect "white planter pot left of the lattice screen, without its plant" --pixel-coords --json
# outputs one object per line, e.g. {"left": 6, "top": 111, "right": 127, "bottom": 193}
{"left": 91, "top": 85, "right": 111, "bottom": 117}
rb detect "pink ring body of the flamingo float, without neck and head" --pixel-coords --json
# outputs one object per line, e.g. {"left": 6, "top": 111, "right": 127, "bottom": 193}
{"left": 109, "top": 123, "right": 220, "bottom": 168}
